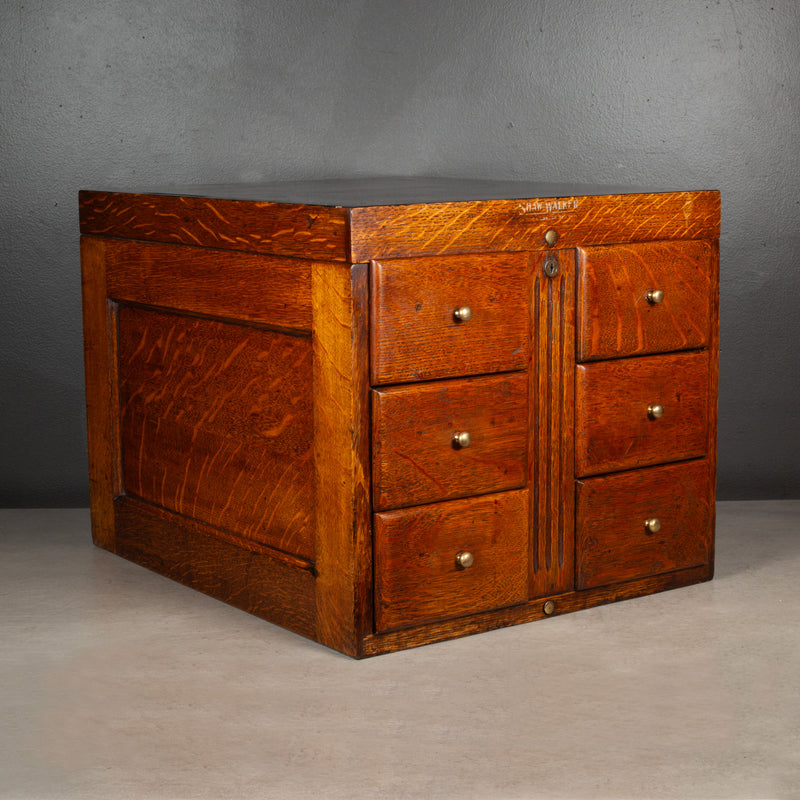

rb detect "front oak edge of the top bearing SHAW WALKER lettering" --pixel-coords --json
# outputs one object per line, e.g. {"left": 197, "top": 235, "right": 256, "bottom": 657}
{"left": 350, "top": 191, "right": 720, "bottom": 261}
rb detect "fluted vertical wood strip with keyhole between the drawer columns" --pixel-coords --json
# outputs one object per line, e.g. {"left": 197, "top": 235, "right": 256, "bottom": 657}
{"left": 529, "top": 251, "right": 575, "bottom": 597}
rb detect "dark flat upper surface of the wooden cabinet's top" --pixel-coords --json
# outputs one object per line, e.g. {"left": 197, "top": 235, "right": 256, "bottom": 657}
{"left": 81, "top": 177, "right": 720, "bottom": 209}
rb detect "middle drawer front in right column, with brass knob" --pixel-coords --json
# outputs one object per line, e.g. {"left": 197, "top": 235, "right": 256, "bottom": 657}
{"left": 575, "top": 352, "right": 709, "bottom": 476}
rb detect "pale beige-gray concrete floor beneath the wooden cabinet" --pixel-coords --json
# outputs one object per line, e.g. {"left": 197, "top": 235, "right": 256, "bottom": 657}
{"left": 0, "top": 501, "right": 800, "bottom": 800}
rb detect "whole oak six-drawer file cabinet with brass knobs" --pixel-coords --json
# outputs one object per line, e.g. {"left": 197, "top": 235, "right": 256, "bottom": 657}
{"left": 80, "top": 179, "right": 720, "bottom": 657}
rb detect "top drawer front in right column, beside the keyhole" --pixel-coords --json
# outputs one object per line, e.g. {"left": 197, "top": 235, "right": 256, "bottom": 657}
{"left": 577, "top": 241, "right": 713, "bottom": 361}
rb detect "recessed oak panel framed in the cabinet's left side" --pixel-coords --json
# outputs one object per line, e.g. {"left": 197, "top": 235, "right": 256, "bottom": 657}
{"left": 119, "top": 306, "right": 314, "bottom": 559}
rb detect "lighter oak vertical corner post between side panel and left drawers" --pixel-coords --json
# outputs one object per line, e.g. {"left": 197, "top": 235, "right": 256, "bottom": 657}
{"left": 311, "top": 263, "right": 372, "bottom": 656}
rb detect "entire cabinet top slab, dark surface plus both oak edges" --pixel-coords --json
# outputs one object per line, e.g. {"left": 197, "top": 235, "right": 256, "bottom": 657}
{"left": 80, "top": 178, "right": 720, "bottom": 263}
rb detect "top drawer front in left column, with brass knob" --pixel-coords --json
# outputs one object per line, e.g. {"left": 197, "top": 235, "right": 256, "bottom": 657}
{"left": 371, "top": 253, "right": 530, "bottom": 384}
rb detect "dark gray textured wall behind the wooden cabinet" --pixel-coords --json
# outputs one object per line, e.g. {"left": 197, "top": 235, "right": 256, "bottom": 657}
{"left": 0, "top": 0, "right": 800, "bottom": 506}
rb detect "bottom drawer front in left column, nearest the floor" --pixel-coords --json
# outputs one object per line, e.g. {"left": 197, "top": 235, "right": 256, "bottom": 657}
{"left": 375, "top": 490, "right": 528, "bottom": 631}
